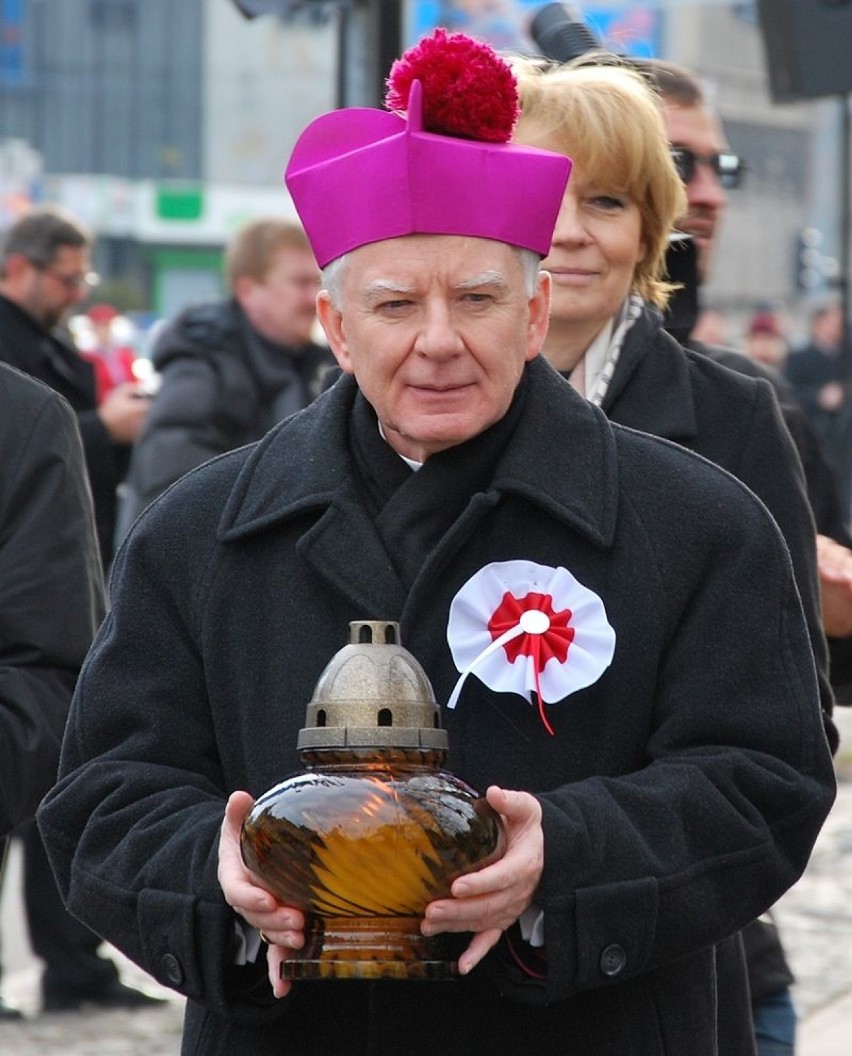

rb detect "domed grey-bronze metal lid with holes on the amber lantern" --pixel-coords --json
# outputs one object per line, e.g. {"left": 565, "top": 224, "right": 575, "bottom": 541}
{"left": 297, "top": 620, "right": 448, "bottom": 752}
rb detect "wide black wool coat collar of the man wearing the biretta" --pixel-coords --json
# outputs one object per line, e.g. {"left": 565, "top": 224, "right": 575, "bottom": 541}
{"left": 219, "top": 357, "right": 619, "bottom": 619}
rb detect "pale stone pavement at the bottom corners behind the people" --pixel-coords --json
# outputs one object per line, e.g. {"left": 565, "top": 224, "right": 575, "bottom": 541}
{"left": 0, "top": 709, "right": 852, "bottom": 1056}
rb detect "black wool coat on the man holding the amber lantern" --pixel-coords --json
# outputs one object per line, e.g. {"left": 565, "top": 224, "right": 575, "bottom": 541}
{"left": 39, "top": 359, "right": 834, "bottom": 1056}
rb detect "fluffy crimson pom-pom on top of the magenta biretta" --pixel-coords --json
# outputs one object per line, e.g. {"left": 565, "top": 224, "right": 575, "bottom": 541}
{"left": 384, "top": 29, "right": 519, "bottom": 143}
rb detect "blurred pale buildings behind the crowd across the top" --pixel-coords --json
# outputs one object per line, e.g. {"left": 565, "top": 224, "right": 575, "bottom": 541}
{"left": 0, "top": 0, "right": 852, "bottom": 337}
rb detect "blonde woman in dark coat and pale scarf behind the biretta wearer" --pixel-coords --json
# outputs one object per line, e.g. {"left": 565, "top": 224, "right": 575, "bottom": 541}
{"left": 508, "top": 60, "right": 837, "bottom": 1056}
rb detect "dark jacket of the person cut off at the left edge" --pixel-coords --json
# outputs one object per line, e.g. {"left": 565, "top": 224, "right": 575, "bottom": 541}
{"left": 0, "top": 363, "right": 103, "bottom": 1021}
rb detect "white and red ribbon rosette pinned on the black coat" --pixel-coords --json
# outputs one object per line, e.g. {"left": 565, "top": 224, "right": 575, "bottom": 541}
{"left": 447, "top": 561, "right": 616, "bottom": 734}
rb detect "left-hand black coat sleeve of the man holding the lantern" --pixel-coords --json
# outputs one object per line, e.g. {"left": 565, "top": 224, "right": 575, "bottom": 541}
{"left": 38, "top": 475, "right": 274, "bottom": 1018}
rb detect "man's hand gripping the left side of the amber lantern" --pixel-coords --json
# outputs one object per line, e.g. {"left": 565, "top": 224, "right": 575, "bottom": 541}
{"left": 219, "top": 792, "right": 305, "bottom": 997}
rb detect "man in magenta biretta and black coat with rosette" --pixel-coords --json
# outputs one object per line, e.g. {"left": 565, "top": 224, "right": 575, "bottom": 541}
{"left": 39, "top": 31, "right": 834, "bottom": 1056}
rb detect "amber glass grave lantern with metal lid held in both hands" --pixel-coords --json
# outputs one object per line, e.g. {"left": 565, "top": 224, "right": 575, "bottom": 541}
{"left": 242, "top": 621, "right": 503, "bottom": 979}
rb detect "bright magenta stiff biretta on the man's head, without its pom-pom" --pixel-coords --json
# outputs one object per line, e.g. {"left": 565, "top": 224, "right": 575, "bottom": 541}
{"left": 285, "top": 31, "right": 571, "bottom": 267}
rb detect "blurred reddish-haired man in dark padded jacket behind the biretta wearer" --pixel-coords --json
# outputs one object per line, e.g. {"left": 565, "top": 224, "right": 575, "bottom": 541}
{"left": 119, "top": 218, "right": 335, "bottom": 534}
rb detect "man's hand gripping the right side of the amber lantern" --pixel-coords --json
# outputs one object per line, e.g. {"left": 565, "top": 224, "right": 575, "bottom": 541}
{"left": 420, "top": 785, "right": 545, "bottom": 976}
